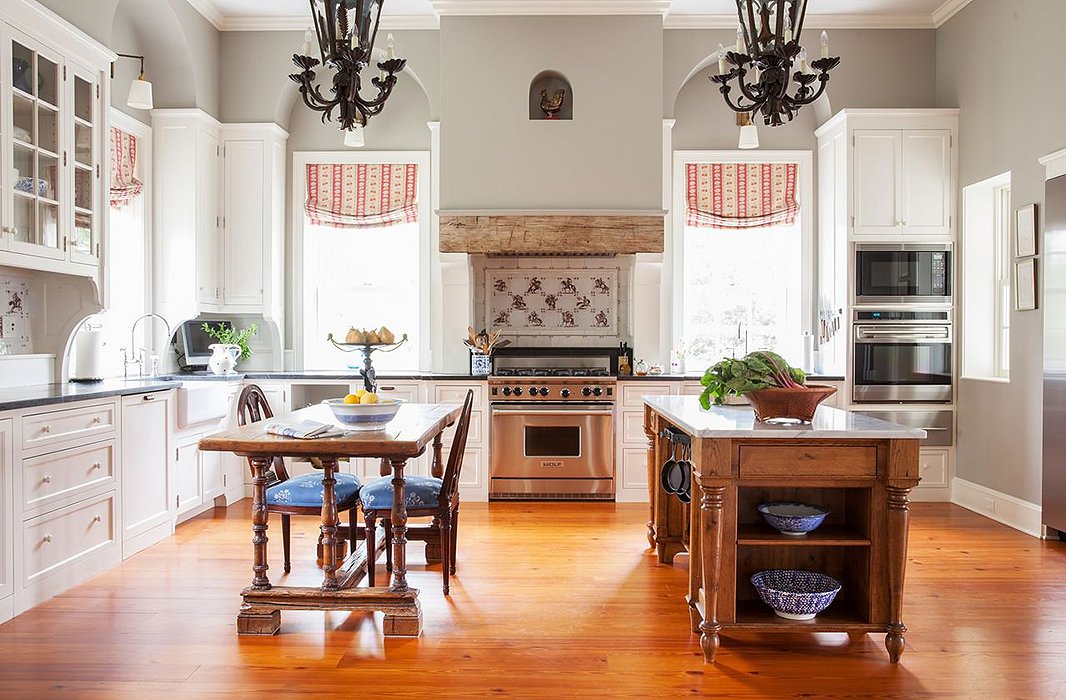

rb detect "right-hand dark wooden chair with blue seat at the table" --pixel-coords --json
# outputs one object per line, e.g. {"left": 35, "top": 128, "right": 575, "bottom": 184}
{"left": 359, "top": 391, "right": 473, "bottom": 596}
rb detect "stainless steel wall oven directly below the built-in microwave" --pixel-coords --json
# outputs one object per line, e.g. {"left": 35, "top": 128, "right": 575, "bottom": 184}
{"left": 852, "top": 310, "right": 954, "bottom": 404}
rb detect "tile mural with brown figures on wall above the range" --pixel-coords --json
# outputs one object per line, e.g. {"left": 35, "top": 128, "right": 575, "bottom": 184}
{"left": 485, "top": 267, "right": 618, "bottom": 336}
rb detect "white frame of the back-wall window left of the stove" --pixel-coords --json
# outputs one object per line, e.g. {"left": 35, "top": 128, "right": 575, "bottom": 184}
{"left": 289, "top": 150, "right": 433, "bottom": 370}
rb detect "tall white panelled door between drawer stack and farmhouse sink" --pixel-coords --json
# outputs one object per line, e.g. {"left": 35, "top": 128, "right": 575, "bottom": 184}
{"left": 122, "top": 392, "right": 173, "bottom": 557}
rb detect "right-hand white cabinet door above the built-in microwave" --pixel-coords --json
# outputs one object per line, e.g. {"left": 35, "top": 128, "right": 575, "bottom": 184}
{"left": 901, "top": 129, "right": 952, "bottom": 237}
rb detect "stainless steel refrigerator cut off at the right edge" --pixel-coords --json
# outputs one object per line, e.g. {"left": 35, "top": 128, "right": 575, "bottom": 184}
{"left": 1037, "top": 176, "right": 1066, "bottom": 539}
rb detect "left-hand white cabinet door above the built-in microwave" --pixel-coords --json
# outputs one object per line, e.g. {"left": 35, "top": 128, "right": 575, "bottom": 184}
{"left": 852, "top": 130, "right": 903, "bottom": 235}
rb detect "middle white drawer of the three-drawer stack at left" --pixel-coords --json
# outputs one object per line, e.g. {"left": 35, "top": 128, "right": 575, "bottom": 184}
{"left": 22, "top": 440, "right": 115, "bottom": 510}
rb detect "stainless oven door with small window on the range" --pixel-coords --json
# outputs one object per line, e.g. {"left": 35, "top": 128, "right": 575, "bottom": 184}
{"left": 489, "top": 404, "right": 614, "bottom": 500}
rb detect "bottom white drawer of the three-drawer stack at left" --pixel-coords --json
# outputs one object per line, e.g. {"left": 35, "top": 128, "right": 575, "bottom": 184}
{"left": 22, "top": 491, "right": 115, "bottom": 587}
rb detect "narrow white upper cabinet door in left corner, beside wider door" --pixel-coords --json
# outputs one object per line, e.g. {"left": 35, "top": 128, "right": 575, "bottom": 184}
{"left": 196, "top": 129, "right": 223, "bottom": 311}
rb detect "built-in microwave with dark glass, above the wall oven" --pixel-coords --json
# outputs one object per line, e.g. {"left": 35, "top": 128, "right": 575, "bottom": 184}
{"left": 855, "top": 243, "right": 952, "bottom": 306}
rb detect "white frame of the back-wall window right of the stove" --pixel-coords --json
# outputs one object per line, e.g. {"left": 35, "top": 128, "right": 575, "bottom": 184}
{"left": 662, "top": 149, "right": 818, "bottom": 362}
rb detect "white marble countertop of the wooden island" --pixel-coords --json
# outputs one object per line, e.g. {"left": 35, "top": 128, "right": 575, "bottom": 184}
{"left": 644, "top": 396, "right": 925, "bottom": 440}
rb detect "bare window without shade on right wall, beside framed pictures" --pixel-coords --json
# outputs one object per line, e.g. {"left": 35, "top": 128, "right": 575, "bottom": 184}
{"left": 960, "top": 173, "right": 1012, "bottom": 380}
